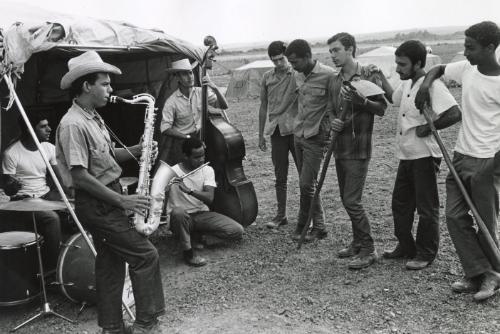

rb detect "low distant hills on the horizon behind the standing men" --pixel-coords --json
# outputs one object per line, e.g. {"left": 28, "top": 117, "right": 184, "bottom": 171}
{"left": 222, "top": 26, "right": 467, "bottom": 53}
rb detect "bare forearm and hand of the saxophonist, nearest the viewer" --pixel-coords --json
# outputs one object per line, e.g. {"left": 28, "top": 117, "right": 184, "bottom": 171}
{"left": 71, "top": 166, "right": 149, "bottom": 214}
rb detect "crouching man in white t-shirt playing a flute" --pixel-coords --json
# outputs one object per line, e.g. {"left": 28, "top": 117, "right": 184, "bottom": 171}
{"left": 167, "top": 138, "right": 243, "bottom": 267}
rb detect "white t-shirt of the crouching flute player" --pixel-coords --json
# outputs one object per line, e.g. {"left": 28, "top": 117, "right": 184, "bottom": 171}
{"left": 167, "top": 164, "right": 217, "bottom": 214}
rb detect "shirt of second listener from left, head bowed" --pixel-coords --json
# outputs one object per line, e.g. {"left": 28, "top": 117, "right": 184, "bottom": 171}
{"left": 293, "top": 60, "right": 337, "bottom": 138}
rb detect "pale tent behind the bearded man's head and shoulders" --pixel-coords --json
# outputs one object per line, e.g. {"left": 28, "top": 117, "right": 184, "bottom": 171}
{"left": 357, "top": 46, "right": 441, "bottom": 88}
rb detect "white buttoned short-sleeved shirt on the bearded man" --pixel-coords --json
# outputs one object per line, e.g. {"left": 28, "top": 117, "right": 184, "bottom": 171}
{"left": 392, "top": 77, "right": 457, "bottom": 160}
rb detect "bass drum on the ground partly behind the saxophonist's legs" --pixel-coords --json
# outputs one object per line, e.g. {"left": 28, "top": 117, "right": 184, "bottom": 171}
{"left": 56, "top": 233, "right": 134, "bottom": 307}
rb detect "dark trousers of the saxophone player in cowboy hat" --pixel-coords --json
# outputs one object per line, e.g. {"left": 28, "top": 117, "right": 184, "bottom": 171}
{"left": 75, "top": 182, "right": 165, "bottom": 328}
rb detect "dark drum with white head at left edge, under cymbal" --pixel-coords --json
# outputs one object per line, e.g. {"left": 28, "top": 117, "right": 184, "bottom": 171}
{"left": 0, "top": 231, "right": 43, "bottom": 306}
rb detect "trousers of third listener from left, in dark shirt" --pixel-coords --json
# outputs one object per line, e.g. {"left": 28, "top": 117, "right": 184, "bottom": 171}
{"left": 335, "top": 159, "right": 375, "bottom": 252}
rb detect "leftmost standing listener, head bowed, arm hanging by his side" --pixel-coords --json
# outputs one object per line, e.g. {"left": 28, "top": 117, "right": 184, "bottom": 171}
{"left": 259, "top": 41, "right": 297, "bottom": 228}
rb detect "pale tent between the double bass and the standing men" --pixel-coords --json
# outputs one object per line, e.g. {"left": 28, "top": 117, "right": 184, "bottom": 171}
{"left": 226, "top": 59, "right": 274, "bottom": 99}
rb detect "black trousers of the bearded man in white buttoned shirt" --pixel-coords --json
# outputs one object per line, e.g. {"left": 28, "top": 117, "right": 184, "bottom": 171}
{"left": 392, "top": 157, "right": 441, "bottom": 261}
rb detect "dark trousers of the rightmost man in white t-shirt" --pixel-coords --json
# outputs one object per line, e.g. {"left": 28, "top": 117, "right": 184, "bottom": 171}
{"left": 446, "top": 152, "right": 498, "bottom": 278}
